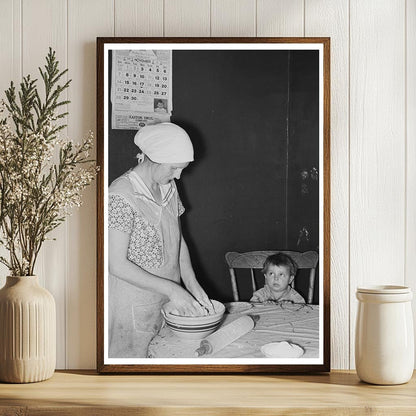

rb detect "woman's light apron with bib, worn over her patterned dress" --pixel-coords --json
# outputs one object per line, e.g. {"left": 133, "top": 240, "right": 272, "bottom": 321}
{"left": 108, "top": 171, "right": 181, "bottom": 358}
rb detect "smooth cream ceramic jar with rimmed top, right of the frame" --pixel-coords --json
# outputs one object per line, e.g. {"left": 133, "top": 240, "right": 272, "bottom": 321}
{"left": 355, "top": 286, "right": 414, "bottom": 384}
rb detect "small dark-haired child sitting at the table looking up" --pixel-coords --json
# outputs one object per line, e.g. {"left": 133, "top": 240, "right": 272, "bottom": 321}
{"left": 250, "top": 253, "right": 305, "bottom": 303}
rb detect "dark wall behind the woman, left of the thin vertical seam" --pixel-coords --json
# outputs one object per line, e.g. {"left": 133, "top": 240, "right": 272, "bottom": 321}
{"left": 109, "top": 51, "right": 318, "bottom": 301}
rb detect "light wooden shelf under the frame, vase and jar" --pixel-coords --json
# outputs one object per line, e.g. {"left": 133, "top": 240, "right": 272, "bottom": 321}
{"left": 0, "top": 371, "right": 416, "bottom": 416}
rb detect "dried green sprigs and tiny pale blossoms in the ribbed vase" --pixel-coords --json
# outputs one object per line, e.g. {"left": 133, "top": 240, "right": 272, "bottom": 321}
{"left": 0, "top": 48, "right": 97, "bottom": 276}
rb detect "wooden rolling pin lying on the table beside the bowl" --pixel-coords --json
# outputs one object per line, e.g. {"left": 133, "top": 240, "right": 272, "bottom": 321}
{"left": 195, "top": 315, "right": 260, "bottom": 357}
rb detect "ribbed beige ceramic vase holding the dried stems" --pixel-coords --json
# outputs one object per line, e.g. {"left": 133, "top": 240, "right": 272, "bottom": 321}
{"left": 0, "top": 276, "right": 56, "bottom": 383}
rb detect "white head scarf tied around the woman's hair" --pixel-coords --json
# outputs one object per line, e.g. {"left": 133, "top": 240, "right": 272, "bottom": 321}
{"left": 134, "top": 123, "right": 194, "bottom": 163}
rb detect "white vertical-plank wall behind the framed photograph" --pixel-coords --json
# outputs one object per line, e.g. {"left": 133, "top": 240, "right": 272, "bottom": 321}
{"left": 0, "top": 0, "right": 416, "bottom": 369}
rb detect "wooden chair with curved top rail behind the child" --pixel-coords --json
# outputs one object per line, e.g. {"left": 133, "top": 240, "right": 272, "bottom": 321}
{"left": 225, "top": 250, "right": 319, "bottom": 303}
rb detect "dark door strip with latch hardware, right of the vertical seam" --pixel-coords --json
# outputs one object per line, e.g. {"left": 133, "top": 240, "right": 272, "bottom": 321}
{"left": 287, "top": 51, "right": 319, "bottom": 303}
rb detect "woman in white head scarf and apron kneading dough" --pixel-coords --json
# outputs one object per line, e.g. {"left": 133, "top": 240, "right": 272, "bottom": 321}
{"left": 108, "top": 123, "right": 212, "bottom": 358}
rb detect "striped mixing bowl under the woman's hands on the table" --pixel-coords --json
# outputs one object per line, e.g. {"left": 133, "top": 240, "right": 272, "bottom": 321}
{"left": 162, "top": 300, "right": 225, "bottom": 340}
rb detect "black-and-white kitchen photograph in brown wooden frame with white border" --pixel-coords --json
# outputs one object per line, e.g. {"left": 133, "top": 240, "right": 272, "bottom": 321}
{"left": 97, "top": 38, "right": 330, "bottom": 373}
